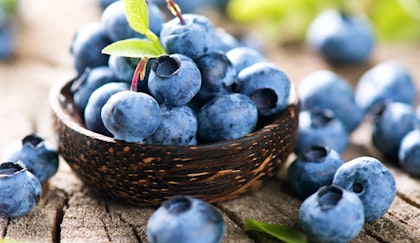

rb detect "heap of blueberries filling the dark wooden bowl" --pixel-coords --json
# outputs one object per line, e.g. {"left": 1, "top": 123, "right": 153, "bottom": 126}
{"left": 72, "top": 1, "right": 291, "bottom": 145}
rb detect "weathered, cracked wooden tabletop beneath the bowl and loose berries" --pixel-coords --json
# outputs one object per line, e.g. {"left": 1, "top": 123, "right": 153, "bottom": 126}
{"left": 0, "top": 0, "right": 420, "bottom": 242}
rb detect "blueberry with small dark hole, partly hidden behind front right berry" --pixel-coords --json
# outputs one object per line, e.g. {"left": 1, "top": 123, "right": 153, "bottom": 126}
{"left": 333, "top": 157, "right": 396, "bottom": 222}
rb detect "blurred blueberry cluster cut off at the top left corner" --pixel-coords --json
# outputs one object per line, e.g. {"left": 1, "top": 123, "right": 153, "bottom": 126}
{"left": 0, "top": 0, "right": 18, "bottom": 60}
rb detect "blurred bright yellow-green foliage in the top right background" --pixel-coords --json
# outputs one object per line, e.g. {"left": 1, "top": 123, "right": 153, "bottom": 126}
{"left": 226, "top": 0, "right": 420, "bottom": 43}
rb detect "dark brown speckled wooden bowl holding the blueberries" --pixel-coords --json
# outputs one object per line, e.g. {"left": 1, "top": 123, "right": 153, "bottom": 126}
{"left": 50, "top": 80, "right": 299, "bottom": 206}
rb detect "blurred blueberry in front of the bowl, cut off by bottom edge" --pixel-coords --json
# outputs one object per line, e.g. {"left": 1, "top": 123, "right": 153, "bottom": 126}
{"left": 146, "top": 195, "right": 226, "bottom": 243}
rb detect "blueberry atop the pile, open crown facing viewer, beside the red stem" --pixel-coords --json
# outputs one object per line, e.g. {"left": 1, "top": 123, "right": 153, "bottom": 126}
{"left": 148, "top": 54, "right": 201, "bottom": 105}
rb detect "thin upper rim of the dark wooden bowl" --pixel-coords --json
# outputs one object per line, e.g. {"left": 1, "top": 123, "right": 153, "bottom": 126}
{"left": 49, "top": 78, "right": 299, "bottom": 150}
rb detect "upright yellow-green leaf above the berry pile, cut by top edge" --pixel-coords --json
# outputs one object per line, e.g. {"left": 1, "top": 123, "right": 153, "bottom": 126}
{"left": 124, "top": 0, "right": 149, "bottom": 35}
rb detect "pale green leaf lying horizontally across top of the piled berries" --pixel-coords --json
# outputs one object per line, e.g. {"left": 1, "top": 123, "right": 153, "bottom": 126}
{"left": 102, "top": 38, "right": 164, "bottom": 58}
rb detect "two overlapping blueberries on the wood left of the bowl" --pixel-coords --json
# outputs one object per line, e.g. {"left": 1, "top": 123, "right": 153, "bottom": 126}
{"left": 0, "top": 134, "right": 59, "bottom": 218}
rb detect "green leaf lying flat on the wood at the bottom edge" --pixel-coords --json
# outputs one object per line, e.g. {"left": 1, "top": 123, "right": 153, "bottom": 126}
{"left": 245, "top": 218, "right": 308, "bottom": 243}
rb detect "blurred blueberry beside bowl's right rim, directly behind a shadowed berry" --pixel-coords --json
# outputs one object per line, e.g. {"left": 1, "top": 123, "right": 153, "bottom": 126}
{"left": 295, "top": 109, "right": 349, "bottom": 154}
